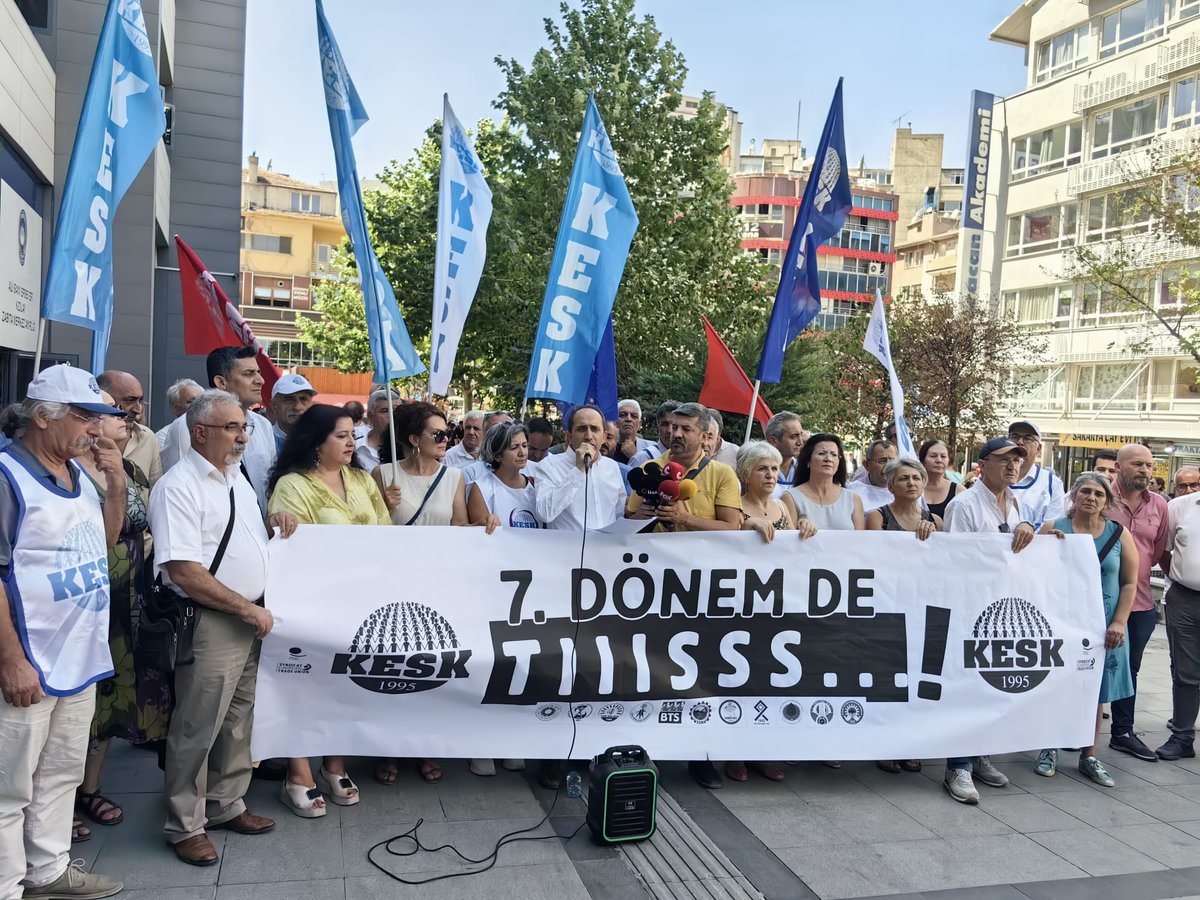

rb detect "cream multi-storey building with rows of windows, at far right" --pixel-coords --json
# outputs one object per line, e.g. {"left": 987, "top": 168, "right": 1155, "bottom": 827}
{"left": 988, "top": 0, "right": 1200, "bottom": 487}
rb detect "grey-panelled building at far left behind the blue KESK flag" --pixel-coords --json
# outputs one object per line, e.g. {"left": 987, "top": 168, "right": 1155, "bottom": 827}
{"left": 0, "top": 0, "right": 246, "bottom": 422}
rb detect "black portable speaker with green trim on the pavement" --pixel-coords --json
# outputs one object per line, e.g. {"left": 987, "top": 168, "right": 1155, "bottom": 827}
{"left": 588, "top": 746, "right": 659, "bottom": 844}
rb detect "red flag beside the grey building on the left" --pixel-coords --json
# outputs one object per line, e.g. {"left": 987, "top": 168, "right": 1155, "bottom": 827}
{"left": 175, "top": 234, "right": 283, "bottom": 404}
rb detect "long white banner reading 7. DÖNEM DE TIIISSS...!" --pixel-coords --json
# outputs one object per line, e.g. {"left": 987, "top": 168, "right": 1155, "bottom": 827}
{"left": 252, "top": 526, "right": 1105, "bottom": 760}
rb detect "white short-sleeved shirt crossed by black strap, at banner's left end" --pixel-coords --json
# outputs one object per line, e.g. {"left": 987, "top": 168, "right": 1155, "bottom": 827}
{"left": 148, "top": 451, "right": 270, "bottom": 601}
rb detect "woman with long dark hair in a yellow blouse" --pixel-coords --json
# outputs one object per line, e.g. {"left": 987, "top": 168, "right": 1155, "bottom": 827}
{"left": 266, "top": 403, "right": 389, "bottom": 818}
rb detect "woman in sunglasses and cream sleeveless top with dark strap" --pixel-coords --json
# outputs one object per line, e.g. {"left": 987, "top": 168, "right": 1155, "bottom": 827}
{"left": 371, "top": 403, "right": 468, "bottom": 785}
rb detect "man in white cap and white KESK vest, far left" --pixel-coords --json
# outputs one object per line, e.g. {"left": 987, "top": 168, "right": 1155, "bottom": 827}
{"left": 0, "top": 366, "right": 126, "bottom": 898}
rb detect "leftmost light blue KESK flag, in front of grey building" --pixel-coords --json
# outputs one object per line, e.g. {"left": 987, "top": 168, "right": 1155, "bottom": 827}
{"left": 42, "top": 0, "right": 167, "bottom": 372}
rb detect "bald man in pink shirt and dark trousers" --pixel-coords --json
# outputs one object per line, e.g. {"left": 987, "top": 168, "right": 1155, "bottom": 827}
{"left": 1106, "top": 444, "right": 1168, "bottom": 762}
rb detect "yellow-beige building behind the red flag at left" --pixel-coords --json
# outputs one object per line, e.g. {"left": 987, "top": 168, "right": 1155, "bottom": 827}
{"left": 239, "top": 154, "right": 346, "bottom": 367}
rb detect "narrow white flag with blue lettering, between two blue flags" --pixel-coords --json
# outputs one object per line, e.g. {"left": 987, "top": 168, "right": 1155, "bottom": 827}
{"left": 430, "top": 95, "right": 492, "bottom": 394}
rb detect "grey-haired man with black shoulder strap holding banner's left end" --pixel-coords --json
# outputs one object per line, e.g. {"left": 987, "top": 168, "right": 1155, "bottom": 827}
{"left": 149, "top": 390, "right": 296, "bottom": 865}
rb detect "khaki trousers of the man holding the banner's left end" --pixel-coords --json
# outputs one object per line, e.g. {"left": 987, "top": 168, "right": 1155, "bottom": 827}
{"left": 163, "top": 608, "right": 258, "bottom": 844}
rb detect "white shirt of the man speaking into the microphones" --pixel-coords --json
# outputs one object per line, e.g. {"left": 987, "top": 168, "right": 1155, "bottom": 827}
{"left": 534, "top": 448, "right": 625, "bottom": 532}
